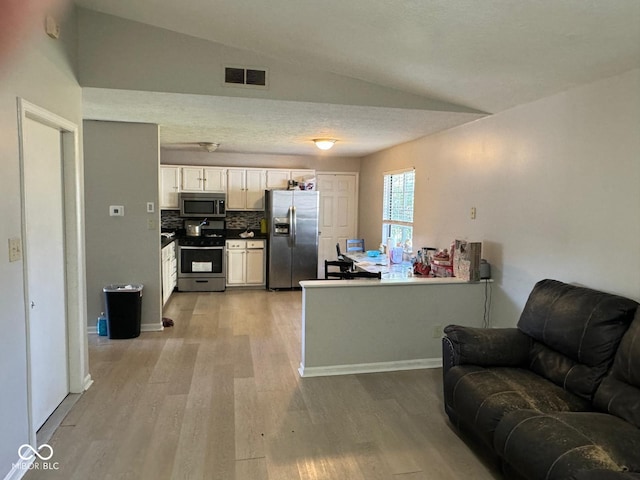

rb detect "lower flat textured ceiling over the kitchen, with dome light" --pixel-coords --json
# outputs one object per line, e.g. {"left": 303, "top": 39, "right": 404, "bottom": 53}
{"left": 83, "top": 88, "right": 478, "bottom": 157}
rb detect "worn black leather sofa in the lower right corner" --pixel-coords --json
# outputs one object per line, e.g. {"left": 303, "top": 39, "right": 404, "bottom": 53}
{"left": 443, "top": 280, "right": 640, "bottom": 480}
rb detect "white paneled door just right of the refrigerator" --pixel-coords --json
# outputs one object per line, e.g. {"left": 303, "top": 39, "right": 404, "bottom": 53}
{"left": 317, "top": 174, "right": 357, "bottom": 278}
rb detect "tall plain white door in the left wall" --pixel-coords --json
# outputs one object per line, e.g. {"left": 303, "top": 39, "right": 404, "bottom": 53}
{"left": 23, "top": 118, "right": 69, "bottom": 430}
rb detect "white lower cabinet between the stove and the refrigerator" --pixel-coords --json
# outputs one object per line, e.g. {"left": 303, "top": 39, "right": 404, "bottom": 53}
{"left": 227, "top": 240, "right": 265, "bottom": 287}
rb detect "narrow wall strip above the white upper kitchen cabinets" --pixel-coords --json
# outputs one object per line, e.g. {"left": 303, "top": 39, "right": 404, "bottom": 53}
{"left": 160, "top": 149, "right": 360, "bottom": 172}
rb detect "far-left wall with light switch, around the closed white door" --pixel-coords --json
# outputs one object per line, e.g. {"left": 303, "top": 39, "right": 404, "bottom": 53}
{"left": 0, "top": 4, "right": 88, "bottom": 478}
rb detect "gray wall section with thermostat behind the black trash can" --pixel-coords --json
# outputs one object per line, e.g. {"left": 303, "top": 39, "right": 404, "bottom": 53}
{"left": 84, "top": 121, "right": 162, "bottom": 330}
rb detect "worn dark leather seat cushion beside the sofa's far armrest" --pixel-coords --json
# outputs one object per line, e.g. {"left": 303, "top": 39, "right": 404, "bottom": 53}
{"left": 444, "top": 365, "right": 591, "bottom": 447}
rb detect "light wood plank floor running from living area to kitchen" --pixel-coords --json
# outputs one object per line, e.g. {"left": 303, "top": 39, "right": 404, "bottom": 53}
{"left": 24, "top": 290, "right": 500, "bottom": 480}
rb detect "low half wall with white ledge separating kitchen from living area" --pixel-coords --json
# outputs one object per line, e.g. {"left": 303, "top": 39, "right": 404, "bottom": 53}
{"left": 299, "top": 277, "right": 490, "bottom": 377}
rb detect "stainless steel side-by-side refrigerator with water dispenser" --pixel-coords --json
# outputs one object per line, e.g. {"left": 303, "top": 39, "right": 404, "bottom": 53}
{"left": 265, "top": 190, "right": 319, "bottom": 289}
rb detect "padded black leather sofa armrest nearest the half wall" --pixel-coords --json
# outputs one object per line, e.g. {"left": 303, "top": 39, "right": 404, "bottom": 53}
{"left": 442, "top": 325, "right": 533, "bottom": 373}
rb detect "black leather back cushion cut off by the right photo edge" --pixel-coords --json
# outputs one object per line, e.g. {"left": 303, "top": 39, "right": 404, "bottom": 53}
{"left": 594, "top": 311, "right": 640, "bottom": 428}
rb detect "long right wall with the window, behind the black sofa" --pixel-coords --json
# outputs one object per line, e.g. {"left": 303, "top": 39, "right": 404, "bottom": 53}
{"left": 359, "top": 70, "right": 640, "bottom": 325}
